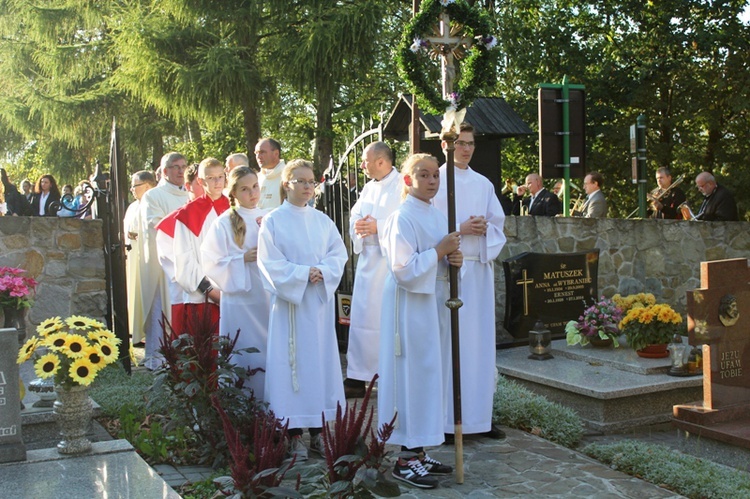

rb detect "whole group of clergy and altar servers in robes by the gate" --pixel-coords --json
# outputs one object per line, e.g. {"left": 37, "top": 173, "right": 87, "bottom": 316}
{"left": 125, "top": 124, "right": 505, "bottom": 488}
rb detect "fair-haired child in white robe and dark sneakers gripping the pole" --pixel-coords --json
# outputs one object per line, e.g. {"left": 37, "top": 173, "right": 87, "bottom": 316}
{"left": 378, "top": 154, "right": 463, "bottom": 488}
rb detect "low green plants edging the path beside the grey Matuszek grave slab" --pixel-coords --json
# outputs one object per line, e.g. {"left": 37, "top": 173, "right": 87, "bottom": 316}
{"left": 493, "top": 376, "right": 583, "bottom": 448}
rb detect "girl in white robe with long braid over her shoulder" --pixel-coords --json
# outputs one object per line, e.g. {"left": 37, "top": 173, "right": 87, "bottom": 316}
{"left": 201, "top": 166, "right": 270, "bottom": 400}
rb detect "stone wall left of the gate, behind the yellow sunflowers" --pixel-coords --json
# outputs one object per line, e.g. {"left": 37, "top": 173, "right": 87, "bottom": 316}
{"left": 0, "top": 217, "right": 107, "bottom": 328}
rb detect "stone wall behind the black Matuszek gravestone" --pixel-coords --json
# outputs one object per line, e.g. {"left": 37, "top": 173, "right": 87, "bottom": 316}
{"left": 495, "top": 217, "right": 750, "bottom": 326}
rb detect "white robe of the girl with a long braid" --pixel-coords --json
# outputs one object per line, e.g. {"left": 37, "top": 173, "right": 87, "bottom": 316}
{"left": 201, "top": 206, "right": 270, "bottom": 400}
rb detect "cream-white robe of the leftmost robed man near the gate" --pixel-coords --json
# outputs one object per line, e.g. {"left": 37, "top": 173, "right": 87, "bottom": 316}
{"left": 122, "top": 199, "right": 145, "bottom": 344}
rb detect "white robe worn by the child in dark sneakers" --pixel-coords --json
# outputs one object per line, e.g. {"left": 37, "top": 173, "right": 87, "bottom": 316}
{"left": 378, "top": 196, "right": 448, "bottom": 449}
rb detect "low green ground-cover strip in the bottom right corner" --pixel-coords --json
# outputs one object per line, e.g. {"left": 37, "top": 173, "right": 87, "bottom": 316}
{"left": 583, "top": 440, "right": 750, "bottom": 499}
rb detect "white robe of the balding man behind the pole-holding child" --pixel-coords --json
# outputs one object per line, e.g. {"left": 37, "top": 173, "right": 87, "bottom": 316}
{"left": 346, "top": 169, "right": 403, "bottom": 381}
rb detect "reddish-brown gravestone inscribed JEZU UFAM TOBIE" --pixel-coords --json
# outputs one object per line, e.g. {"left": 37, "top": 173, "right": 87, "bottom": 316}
{"left": 674, "top": 258, "right": 750, "bottom": 448}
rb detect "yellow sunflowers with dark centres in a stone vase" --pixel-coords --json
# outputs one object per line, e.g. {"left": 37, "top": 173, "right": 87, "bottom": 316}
{"left": 18, "top": 315, "right": 120, "bottom": 454}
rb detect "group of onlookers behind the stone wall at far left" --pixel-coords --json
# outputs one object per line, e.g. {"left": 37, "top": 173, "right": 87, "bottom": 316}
{"left": 0, "top": 168, "right": 91, "bottom": 218}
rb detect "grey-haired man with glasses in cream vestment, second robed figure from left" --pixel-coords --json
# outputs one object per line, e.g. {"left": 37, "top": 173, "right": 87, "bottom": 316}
{"left": 138, "top": 152, "right": 188, "bottom": 369}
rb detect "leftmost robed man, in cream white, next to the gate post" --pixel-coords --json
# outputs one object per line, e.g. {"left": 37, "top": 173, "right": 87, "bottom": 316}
{"left": 122, "top": 170, "right": 156, "bottom": 352}
